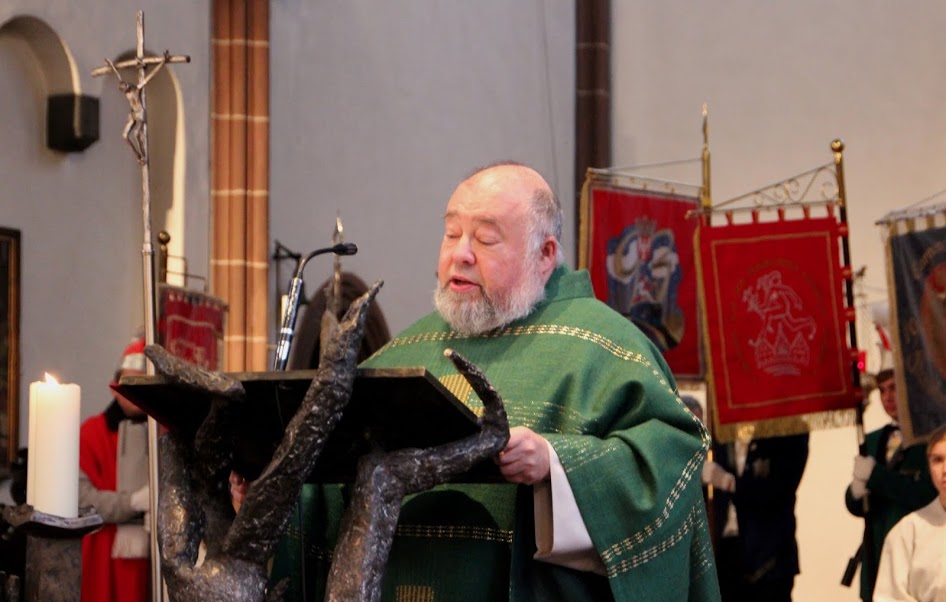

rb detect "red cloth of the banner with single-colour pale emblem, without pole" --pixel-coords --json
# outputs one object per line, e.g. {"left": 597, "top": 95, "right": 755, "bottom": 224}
{"left": 697, "top": 217, "right": 858, "bottom": 424}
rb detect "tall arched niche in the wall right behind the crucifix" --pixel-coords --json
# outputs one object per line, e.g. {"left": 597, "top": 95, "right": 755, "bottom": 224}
{"left": 102, "top": 50, "right": 187, "bottom": 285}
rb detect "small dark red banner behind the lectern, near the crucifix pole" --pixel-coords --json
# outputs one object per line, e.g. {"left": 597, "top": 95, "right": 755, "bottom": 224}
{"left": 158, "top": 284, "right": 227, "bottom": 370}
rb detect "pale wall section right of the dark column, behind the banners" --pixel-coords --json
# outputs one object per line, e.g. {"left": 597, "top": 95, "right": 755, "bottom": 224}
{"left": 612, "top": 0, "right": 946, "bottom": 600}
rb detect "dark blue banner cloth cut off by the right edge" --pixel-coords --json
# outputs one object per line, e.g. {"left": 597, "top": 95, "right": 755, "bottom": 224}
{"left": 887, "top": 221, "right": 946, "bottom": 441}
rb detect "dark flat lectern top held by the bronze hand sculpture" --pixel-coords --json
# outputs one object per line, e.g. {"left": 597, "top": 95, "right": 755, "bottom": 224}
{"left": 112, "top": 367, "right": 500, "bottom": 483}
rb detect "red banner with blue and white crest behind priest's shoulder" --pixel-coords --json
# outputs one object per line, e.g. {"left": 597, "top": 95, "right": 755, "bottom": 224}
{"left": 579, "top": 179, "right": 703, "bottom": 378}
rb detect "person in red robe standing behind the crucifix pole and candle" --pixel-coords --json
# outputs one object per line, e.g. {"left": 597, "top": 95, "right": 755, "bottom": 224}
{"left": 79, "top": 336, "right": 151, "bottom": 602}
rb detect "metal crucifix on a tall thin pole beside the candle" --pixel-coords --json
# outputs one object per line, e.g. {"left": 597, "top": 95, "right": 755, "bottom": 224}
{"left": 92, "top": 11, "right": 191, "bottom": 600}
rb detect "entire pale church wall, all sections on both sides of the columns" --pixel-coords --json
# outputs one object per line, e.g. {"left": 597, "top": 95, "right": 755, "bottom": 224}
{"left": 0, "top": 0, "right": 946, "bottom": 600}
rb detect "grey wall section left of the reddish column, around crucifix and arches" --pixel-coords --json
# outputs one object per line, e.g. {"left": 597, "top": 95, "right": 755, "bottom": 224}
{"left": 0, "top": 0, "right": 210, "bottom": 432}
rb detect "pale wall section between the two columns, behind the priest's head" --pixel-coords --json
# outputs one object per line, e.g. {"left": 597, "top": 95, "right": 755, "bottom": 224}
{"left": 270, "top": 0, "right": 575, "bottom": 331}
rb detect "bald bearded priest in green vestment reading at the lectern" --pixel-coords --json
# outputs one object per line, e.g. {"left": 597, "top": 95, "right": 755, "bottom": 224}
{"left": 235, "top": 162, "right": 719, "bottom": 602}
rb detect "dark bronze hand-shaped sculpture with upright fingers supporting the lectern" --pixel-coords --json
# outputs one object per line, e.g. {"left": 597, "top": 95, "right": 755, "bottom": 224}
{"left": 145, "top": 282, "right": 509, "bottom": 602}
